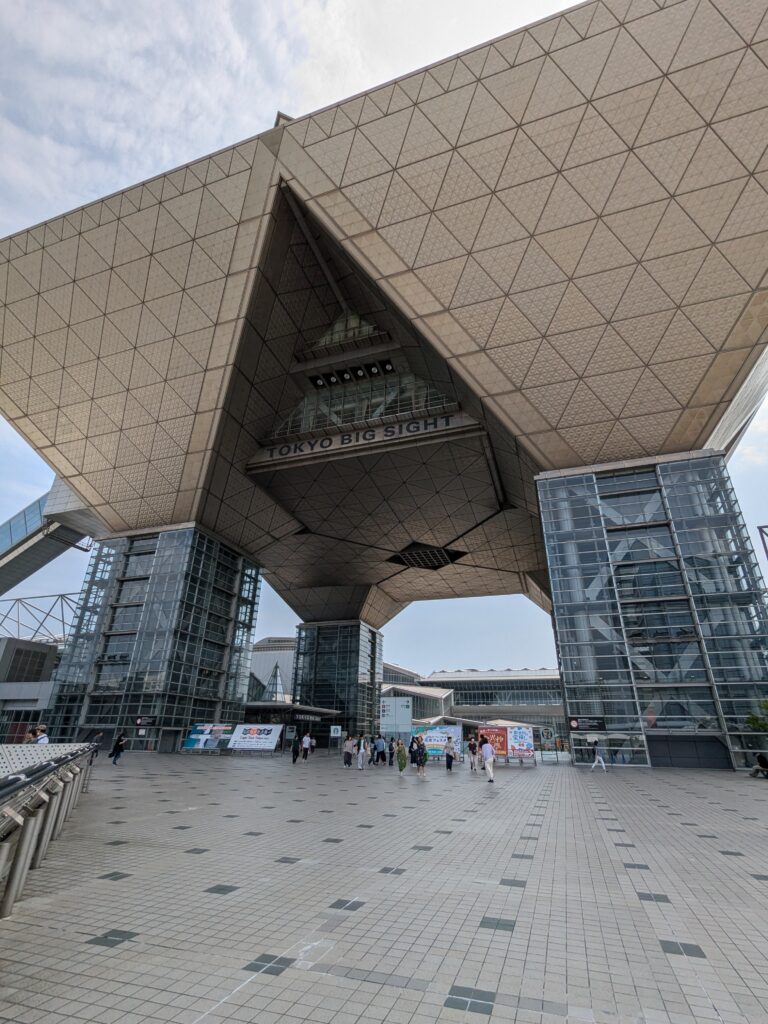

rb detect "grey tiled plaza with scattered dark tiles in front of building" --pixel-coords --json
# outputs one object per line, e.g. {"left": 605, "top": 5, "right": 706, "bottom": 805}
{"left": 0, "top": 752, "right": 768, "bottom": 1024}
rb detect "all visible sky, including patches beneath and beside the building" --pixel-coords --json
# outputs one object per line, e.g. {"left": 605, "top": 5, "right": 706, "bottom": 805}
{"left": 0, "top": 0, "right": 768, "bottom": 674}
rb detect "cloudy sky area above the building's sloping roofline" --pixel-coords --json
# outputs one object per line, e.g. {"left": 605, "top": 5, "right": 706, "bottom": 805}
{"left": 0, "top": 0, "right": 567, "bottom": 237}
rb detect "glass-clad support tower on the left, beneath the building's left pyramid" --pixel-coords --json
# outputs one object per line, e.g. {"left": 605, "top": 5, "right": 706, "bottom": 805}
{"left": 51, "top": 528, "right": 260, "bottom": 750}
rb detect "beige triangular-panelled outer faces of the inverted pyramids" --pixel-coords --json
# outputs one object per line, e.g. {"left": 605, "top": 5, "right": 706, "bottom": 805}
{"left": 0, "top": 0, "right": 768, "bottom": 529}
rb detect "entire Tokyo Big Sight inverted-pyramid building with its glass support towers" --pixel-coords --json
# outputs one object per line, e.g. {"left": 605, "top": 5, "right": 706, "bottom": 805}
{"left": 0, "top": 0, "right": 768, "bottom": 766}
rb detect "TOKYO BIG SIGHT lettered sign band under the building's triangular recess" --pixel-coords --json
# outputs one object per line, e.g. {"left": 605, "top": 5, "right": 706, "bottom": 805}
{"left": 248, "top": 412, "right": 484, "bottom": 473}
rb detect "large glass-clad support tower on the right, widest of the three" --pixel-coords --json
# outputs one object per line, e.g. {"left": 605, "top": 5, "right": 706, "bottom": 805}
{"left": 538, "top": 452, "right": 768, "bottom": 767}
